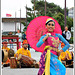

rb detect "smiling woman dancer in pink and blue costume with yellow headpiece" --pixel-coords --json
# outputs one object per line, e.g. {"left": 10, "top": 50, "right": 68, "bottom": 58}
{"left": 36, "top": 18, "right": 70, "bottom": 75}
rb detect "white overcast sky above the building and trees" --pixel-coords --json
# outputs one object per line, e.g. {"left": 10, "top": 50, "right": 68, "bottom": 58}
{"left": 1, "top": 0, "right": 74, "bottom": 18}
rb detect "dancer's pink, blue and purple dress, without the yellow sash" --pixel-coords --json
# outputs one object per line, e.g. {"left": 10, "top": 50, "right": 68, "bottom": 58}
{"left": 36, "top": 32, "right": 70, "bottom": 75}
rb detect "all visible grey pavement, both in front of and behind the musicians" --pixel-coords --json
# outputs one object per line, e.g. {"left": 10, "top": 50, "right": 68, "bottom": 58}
{"left": 1, "top": 43, "right": 74, "bottom": 75}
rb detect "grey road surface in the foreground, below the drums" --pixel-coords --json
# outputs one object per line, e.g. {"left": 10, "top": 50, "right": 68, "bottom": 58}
{"left": 2, "top": 68, "right": 74, "bottom": 75}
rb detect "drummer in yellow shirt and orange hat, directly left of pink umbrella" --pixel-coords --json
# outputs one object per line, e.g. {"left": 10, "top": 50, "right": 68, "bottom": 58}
{"left": 14, "top": 40, "right": 31, "bottom": 58}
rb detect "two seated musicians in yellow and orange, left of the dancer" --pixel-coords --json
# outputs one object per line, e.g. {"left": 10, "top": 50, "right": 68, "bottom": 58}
{"left": 2, "top": 40, "right": 31, "bottom": 66}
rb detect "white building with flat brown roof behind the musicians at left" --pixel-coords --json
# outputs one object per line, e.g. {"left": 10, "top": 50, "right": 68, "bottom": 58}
{"left": 1, "top": 18, "right": 26, "bottom": 33}
